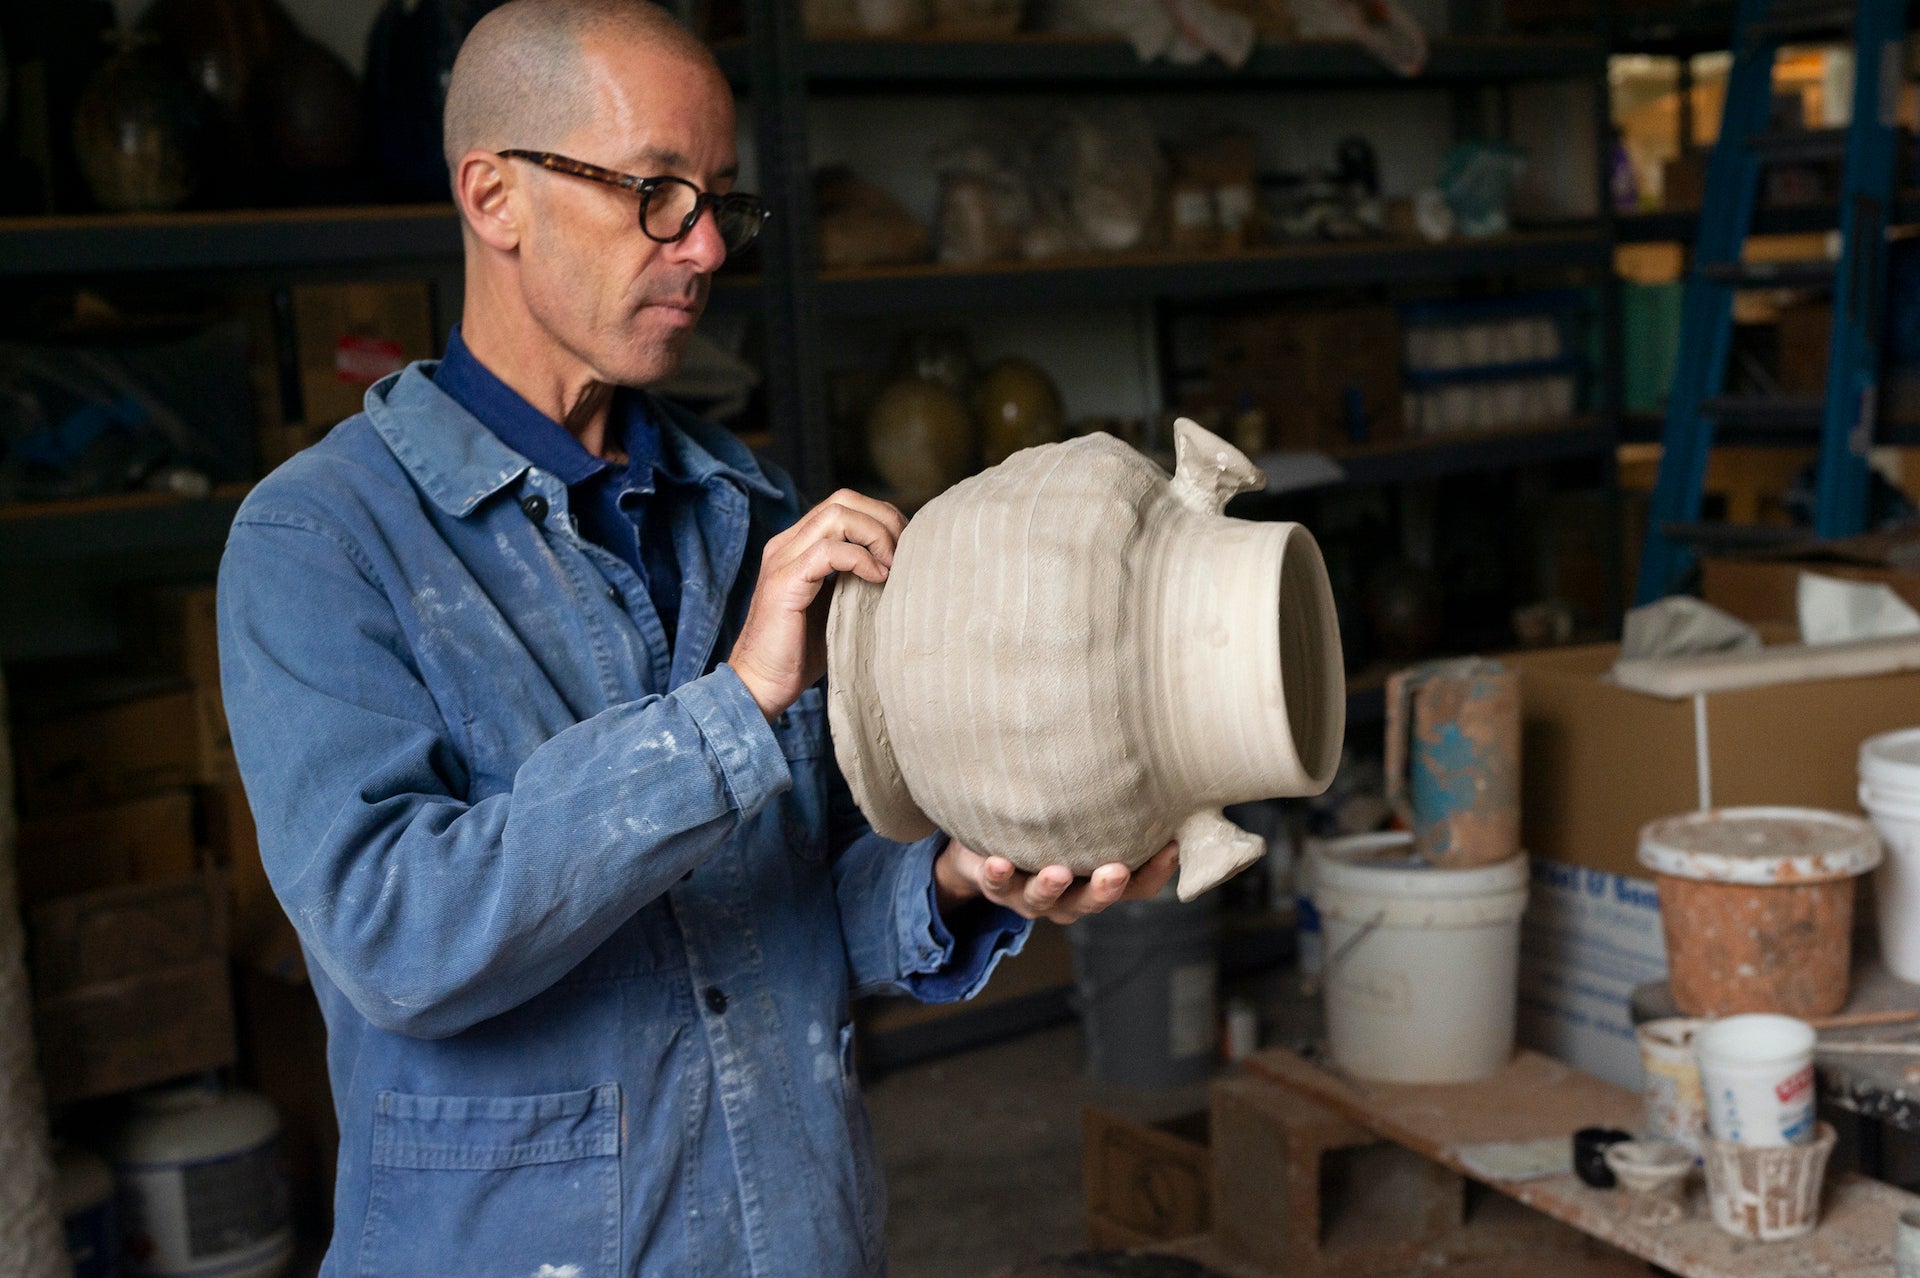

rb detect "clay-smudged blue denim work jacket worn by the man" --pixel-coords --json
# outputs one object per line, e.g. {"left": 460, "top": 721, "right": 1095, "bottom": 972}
{"left": 219, "top": 365, "right": 1025, "bottom": 1278}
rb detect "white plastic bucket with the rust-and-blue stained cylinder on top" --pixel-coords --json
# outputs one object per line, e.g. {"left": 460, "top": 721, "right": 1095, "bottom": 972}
{"left": 1309, "top": 833, "right": 1526, "bottom": 1082}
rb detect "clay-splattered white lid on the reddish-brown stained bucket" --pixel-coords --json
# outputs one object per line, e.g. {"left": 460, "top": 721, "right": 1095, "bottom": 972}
{"left": 1640, "top": 808, "right": 1880, "bottom": 885}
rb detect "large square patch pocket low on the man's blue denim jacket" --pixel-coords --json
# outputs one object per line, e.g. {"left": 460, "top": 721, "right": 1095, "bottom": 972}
{"left": 359, "top": 1082, "right": 620, "bottom": 1278}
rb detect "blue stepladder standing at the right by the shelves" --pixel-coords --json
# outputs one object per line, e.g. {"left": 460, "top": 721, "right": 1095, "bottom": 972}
{"left": 1636, "top": 0, "right": 1907, "bottom": 603}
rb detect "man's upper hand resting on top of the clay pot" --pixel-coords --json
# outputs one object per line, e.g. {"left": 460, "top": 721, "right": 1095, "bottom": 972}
{"left": 726, "top": 487, "right": 906, "bottom": 722}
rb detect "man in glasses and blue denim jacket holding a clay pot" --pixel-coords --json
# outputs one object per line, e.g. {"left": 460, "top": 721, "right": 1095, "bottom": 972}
{"left": 221, "top": 0, "right": 1175, "bottom": 1278}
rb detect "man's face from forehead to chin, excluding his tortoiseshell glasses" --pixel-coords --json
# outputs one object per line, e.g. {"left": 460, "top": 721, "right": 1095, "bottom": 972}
{"left": 520, "top": 40, "right": 735, "bottom": 386}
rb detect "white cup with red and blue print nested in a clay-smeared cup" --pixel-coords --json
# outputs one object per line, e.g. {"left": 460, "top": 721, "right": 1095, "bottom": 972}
{"left": 1693, "top": 1013, "right": 1814, "bottom": 1146}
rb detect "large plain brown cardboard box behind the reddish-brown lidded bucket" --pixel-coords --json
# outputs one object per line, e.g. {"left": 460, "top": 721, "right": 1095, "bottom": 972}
{"left": 1501, "top": 645, "right": 1920, "bottom": 877}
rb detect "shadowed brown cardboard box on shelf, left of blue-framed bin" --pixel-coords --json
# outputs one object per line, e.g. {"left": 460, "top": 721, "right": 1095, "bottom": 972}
{"left": 1208, "top": 307, "right": 1402, "bottom": 449}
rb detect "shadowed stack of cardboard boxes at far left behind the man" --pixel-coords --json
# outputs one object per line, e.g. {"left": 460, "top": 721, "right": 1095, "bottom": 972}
{"left": 13, "top": 594, "right": 236, "bottom": 1101}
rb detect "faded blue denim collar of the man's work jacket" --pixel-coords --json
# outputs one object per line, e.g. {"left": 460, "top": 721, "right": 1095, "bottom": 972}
{"left": 365, "top": 361, "right": 781, "bottom": 518}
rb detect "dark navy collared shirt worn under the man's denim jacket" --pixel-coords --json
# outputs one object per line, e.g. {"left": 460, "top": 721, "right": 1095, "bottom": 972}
{"left": 434, "top": 324, "right": 687, "bottom": 639}
